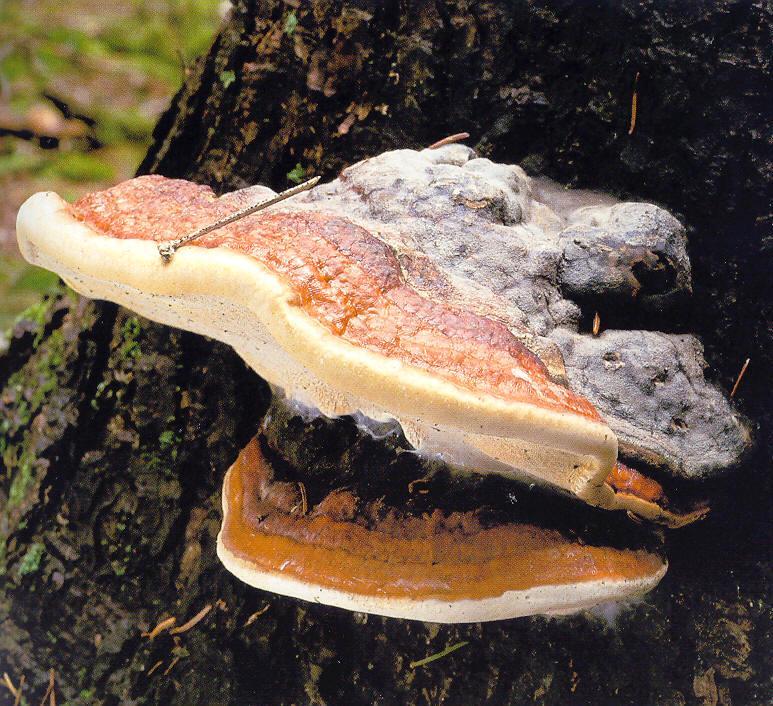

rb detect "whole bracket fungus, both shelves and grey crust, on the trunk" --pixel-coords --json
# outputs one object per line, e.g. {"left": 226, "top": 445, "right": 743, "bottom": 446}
{"left": 17, "top": 144, "right": 749, "bottom": 621}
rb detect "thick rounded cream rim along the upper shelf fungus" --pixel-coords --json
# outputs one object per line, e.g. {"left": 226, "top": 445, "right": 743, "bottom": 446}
{"left": 17, "top": 192, "right": 617, "bottom": 472}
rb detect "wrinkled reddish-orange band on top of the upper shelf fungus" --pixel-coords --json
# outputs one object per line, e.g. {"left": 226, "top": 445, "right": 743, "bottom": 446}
{"left": 72, "top": 176, "right": 600, "bottom": 420}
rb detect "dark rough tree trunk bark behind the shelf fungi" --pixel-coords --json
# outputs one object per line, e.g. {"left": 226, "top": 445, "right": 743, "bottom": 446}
{"left": 0, "top": 0, "right": 773, "bottom": 704}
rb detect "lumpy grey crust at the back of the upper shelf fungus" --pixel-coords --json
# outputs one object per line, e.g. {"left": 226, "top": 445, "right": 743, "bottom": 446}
{"left": 303, "top": 144, "right": 752, "bottom": 478}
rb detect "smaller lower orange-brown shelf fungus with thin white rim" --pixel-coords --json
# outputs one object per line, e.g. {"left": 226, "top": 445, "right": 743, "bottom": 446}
{"left": 217, "top": 439, "right": 667, "bottom": 623}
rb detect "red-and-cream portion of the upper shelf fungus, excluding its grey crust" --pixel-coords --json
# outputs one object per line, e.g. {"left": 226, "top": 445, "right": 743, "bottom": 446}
{"left": 17, "top": 164, "right": 704, "bottom": 524}
